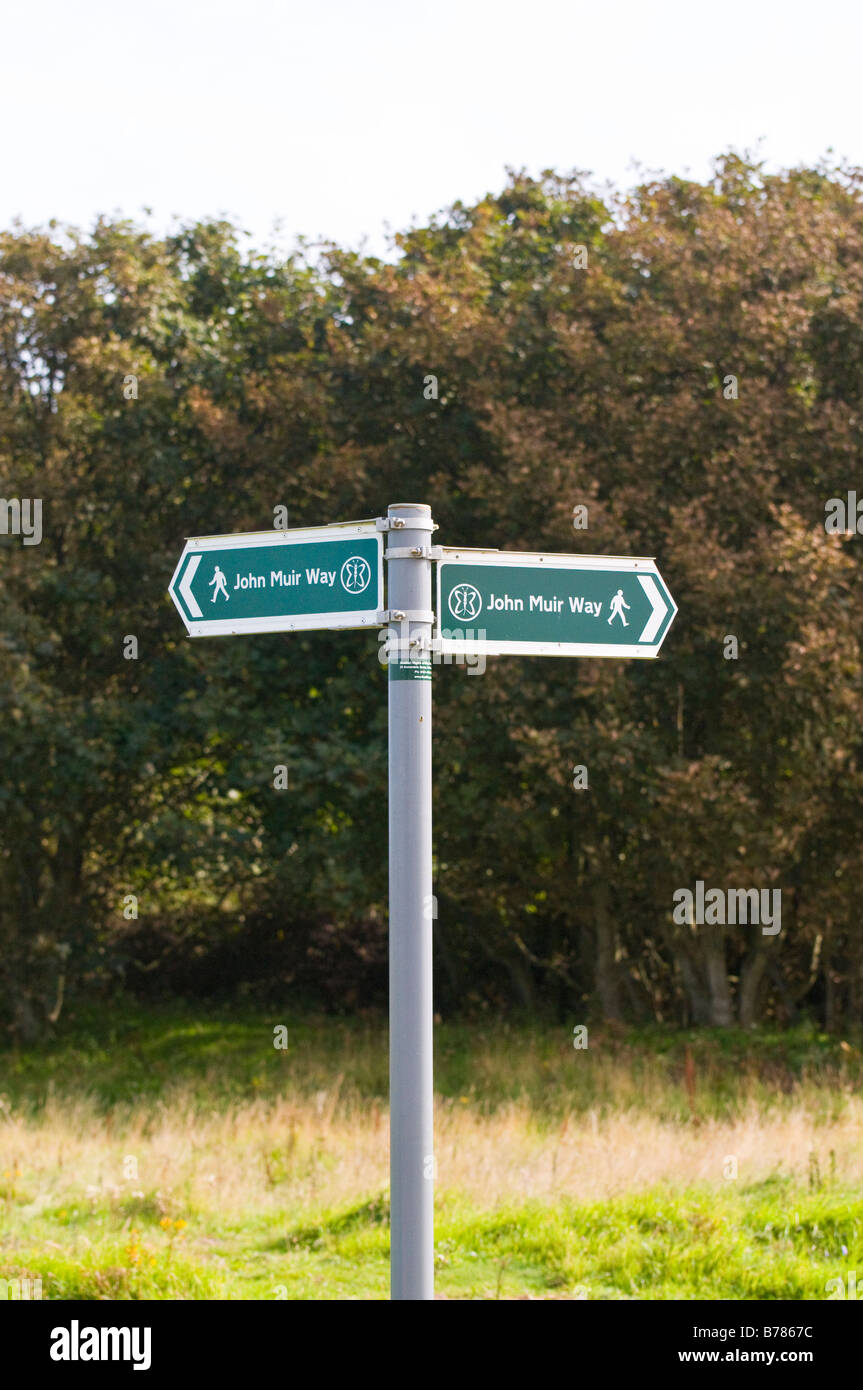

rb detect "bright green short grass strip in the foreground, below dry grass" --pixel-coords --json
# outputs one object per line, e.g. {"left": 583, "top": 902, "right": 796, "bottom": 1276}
{"left": 6, "top": 1186, "right": 863, "bottom": 1301}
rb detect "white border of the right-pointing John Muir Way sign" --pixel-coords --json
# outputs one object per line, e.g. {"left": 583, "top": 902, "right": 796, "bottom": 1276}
{"left": 431, "top": 545, "right": 678, "bottom": 660}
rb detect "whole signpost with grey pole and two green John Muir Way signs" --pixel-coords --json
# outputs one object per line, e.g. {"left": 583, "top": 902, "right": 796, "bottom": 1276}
{"left": 168, "top": 502, "right": 677, "bottom": 1300}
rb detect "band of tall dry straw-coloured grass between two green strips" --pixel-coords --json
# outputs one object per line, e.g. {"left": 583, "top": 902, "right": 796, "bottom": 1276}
{"left": 6, "top": 1086, "right": 863, "bottom": 1213}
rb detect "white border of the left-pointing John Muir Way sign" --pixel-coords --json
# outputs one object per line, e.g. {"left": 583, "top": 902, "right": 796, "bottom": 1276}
{"left": 168, "top": 521, "right": 386, "bottom": 637}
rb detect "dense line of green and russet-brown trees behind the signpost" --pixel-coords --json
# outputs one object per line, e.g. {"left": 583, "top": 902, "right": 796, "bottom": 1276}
{"left": 0, "top": 156, "right": 863, "bottom": 1037}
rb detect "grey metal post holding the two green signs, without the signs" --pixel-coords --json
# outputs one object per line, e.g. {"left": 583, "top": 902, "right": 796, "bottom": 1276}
{"left": 386, "top": 502, "right": 435, "bottom": 1300}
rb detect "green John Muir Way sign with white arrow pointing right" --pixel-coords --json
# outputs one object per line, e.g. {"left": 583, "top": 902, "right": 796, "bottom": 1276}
{"left": 434, "top": 546, "right": 677, "bottom": 656}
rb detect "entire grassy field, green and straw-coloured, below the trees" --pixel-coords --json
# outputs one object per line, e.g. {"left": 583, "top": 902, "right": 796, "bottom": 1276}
{"left": 0, "top": 1005, "right": 863, "bottom": 1300}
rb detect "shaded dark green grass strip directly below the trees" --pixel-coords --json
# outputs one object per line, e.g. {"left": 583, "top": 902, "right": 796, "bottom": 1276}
{"left": 0, "top": 997, "right": 863, "bottom": 1126}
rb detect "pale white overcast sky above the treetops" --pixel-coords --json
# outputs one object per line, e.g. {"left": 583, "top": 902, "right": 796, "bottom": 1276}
{"left": 0, "top": 0, "right": 863, "bottom": 254}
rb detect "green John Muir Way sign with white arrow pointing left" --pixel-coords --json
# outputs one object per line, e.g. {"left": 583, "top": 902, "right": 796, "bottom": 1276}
{"left": 168, "top": 521, "right": 384, "bottom": 637}
